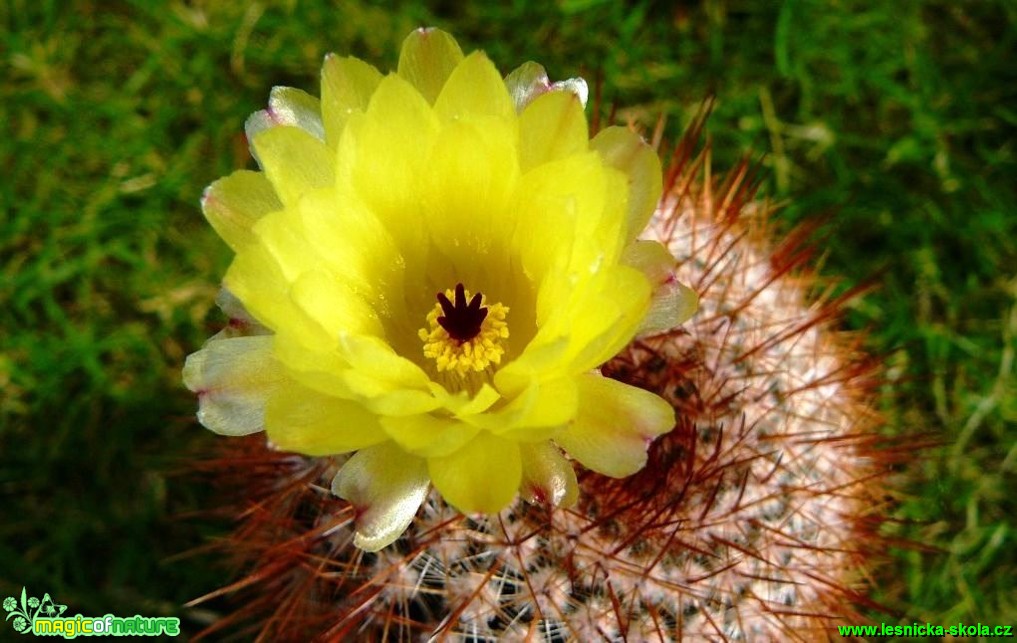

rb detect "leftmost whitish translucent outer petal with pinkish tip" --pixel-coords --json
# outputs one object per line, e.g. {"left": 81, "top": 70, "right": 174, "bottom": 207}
{"left": 183, "top": 335, "right": 285, "bottom": 435}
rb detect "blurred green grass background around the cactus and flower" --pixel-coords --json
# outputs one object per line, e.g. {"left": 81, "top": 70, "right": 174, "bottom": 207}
{"left": 0, "top": 0, "right": 1017, "bottom": 636}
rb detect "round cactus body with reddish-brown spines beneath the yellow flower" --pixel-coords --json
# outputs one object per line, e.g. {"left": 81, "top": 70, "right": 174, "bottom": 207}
{"left": 195, "top": 109, "right": 895, "bottom": 641}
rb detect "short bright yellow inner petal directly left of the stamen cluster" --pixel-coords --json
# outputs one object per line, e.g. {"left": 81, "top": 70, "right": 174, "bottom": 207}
{"left": 290, "top": 270, "right": 384, "bottom": 337}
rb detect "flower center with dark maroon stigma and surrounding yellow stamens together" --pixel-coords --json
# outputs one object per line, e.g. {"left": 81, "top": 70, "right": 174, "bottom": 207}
{"left": 417, "top": 284, "right": 509, "bottom": 377}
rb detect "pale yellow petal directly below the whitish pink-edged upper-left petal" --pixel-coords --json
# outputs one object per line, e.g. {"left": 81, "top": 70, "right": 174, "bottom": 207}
{"left": 254, "top": 126, "right": 336, "bottom": 206}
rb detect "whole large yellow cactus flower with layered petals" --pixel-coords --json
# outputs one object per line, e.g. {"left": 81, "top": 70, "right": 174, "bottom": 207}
{"left": 184, "top": 30, "right": 697, "bottom": 550}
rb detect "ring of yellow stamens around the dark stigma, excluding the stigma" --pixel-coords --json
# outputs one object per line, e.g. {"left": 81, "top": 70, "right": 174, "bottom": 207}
{"left": 417, "top": 289, "right": 509, "bottom": 377}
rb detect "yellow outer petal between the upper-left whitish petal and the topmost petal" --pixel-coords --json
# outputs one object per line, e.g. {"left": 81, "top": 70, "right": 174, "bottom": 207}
{"left": 321, "top": 54, "right": 381, "bottom": 150}
